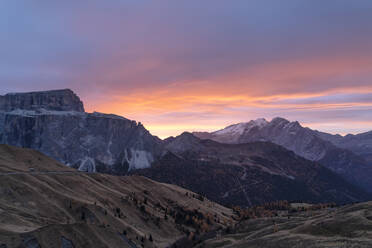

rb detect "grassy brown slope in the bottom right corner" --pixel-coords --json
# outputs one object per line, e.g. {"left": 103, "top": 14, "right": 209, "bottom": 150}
{"left": 201, "top": 202, "right": 372, "bottom": 248}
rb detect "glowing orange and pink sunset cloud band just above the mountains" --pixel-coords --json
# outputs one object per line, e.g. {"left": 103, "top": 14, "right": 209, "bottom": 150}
{"left": 88, "top": 54, "right": 372, "bottom": 137}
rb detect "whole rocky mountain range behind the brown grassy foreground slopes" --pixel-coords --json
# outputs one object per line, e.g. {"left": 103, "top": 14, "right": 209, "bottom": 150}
{"left": 0, "top": 89, "right": 372, "bottom": 206}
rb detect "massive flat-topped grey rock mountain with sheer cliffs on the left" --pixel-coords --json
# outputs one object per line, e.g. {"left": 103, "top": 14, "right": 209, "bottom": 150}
{"left": 0, "top": 89, "right": 162, "bottom": 174}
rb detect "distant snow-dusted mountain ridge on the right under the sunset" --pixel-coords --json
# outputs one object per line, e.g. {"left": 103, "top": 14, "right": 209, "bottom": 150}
{"left": 194, "top": 118, "right": 372, "bottom": 192}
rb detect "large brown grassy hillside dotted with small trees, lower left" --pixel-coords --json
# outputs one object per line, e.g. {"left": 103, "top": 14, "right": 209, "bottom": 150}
{"left": 0, "top": 145, "right": 235, "bottom": 248}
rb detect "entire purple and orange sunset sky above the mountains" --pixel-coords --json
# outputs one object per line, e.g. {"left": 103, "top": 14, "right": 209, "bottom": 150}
{"left": 0, "top": 0, "right": 372, "bottom": 138}
